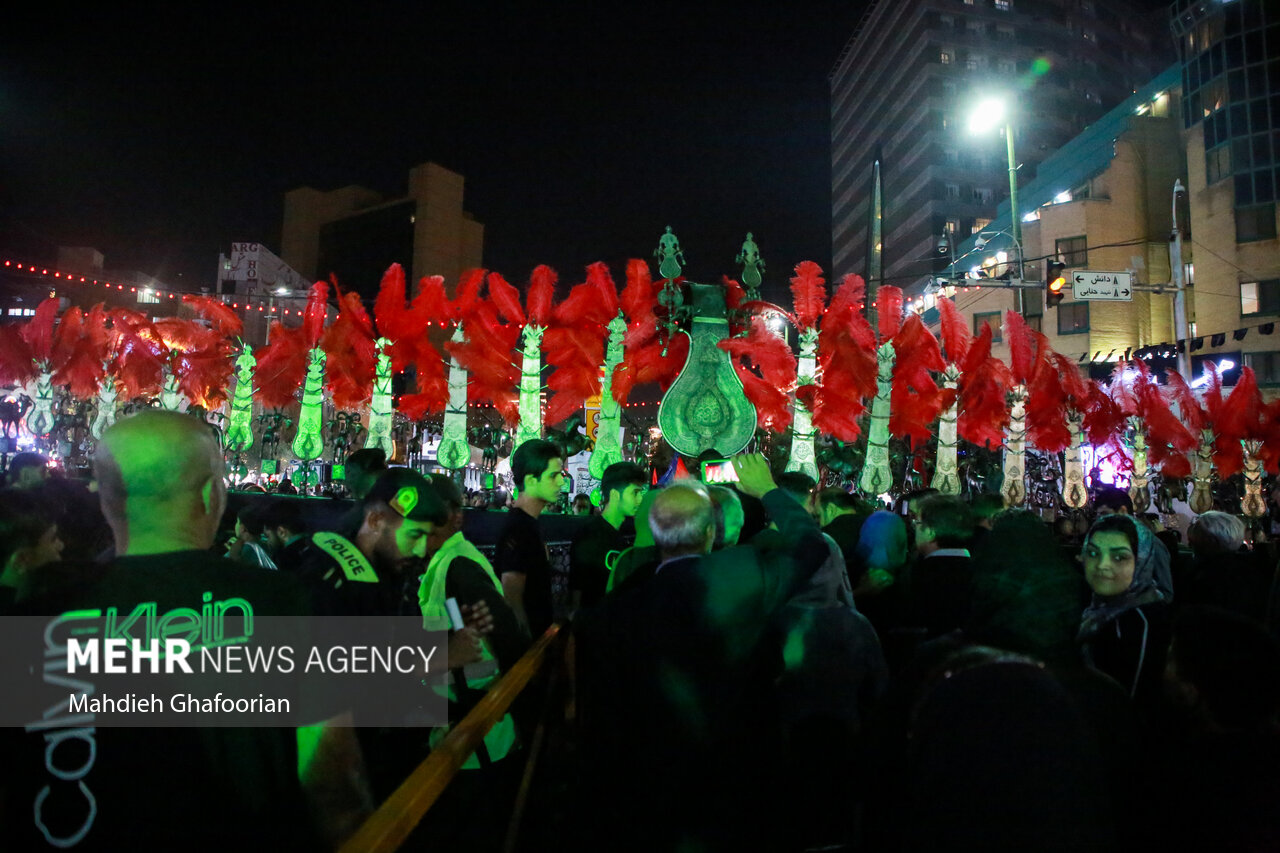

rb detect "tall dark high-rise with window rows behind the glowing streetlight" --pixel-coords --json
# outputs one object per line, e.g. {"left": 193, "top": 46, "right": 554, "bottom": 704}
{"left": 831, "top": 0, "right": 1174, "bottom": 295}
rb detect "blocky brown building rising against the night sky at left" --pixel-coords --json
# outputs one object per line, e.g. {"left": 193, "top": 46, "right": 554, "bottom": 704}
{"left": 280, "top": 163, "right": 484, "bottom": 298}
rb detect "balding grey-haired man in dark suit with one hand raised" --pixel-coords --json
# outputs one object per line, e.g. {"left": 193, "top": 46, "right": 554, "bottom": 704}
{"left": 576, "top": 455, "right": 827, "bottom": 849}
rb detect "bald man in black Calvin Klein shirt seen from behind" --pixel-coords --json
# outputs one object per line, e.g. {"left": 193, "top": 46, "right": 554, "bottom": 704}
{"left": 0, "top": 410, "right": 362, "bottom": 850}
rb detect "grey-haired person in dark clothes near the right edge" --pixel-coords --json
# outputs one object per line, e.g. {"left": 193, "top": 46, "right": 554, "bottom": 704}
{"left": 1175, "top": 510, "right": 1274, "bottom": 621}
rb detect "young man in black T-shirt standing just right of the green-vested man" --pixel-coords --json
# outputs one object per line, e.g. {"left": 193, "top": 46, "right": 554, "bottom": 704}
{"left": 493, "top": 438, "right": 564, "bottom": 639}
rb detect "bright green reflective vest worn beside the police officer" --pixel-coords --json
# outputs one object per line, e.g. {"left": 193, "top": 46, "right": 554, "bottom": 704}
{"left": 417, "top": 530, "right": 516, "bottom": 770}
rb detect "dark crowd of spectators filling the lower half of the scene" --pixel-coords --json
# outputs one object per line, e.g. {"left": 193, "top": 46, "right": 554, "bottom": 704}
{"left": 0, "top": 411, "right": 1280, "bottom": 850}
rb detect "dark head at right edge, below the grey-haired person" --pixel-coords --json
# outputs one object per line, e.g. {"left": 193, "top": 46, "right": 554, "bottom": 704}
{"left": 1165, "top": 607, "right": 1280, "bottom": 733}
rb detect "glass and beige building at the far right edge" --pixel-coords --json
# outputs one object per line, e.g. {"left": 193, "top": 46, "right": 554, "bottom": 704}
{"left": 1171, "top": 0, "right": 1280, "bottom": 387}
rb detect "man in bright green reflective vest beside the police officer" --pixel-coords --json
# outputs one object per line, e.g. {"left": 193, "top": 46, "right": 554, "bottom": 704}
{"left": 417, "top": 474, "right": 529, "bottom": 850}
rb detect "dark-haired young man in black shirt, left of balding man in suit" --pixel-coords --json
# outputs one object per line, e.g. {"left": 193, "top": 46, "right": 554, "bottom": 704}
{"left": 568, "top": 462, "right": 648, "bottom": 611}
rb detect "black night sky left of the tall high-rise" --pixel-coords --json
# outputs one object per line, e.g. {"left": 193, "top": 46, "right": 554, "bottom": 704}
{"left": 0, "top": 0, "right": 865, "bottom": 297}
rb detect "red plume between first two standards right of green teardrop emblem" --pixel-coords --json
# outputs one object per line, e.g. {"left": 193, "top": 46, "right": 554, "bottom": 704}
{"left": 796, "top": 275, "right": 877, "bottom": 442}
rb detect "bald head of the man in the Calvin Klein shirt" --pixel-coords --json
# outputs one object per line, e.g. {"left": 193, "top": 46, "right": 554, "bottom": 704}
{"left": 93, "top": 409, "right": 227, "bottom": 555}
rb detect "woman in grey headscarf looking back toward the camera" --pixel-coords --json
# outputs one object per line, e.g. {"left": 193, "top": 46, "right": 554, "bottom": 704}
{"left": 1076, "top": 515, "right": 1174, "bottom": 699}
